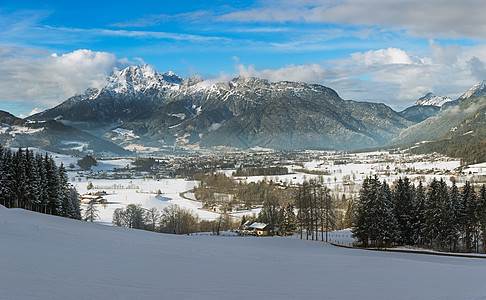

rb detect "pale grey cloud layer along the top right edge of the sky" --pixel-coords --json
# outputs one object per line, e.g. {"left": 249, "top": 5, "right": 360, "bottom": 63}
{"left": 219, "top": 0, "right": 486, "bottom": 39}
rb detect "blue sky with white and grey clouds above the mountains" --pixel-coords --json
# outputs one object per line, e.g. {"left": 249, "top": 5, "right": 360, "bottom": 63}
{"left": 0, "top": 0, "right": 486, "bottom": 115}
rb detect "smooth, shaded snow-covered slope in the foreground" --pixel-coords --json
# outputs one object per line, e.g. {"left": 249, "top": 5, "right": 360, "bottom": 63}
{"left": 0, "top": 207, "right": 486, "bottom": 299}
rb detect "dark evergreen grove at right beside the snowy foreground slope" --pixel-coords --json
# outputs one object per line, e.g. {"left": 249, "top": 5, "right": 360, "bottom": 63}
{"left": 353, "top": 176, "right": 486, "bottom": 252}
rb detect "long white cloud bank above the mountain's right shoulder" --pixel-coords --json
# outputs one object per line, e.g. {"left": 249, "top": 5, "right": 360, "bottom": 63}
{"left": 228, "top": 41, "right": 486, "bottom": 110}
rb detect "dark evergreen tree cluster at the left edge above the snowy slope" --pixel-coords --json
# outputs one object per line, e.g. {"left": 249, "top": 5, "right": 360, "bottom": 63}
{"left": 0, "top": 147, "right": 81, "bottom": 219}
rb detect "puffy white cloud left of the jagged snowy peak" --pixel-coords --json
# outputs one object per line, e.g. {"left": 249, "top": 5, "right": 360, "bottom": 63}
{"left": 0, "top": 50, "right": 129, "bottom": 108}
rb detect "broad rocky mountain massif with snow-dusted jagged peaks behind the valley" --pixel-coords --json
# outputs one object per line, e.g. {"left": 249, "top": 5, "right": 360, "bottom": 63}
{"left": 31, "top": 65, "right": 413, "bottom": 149}
